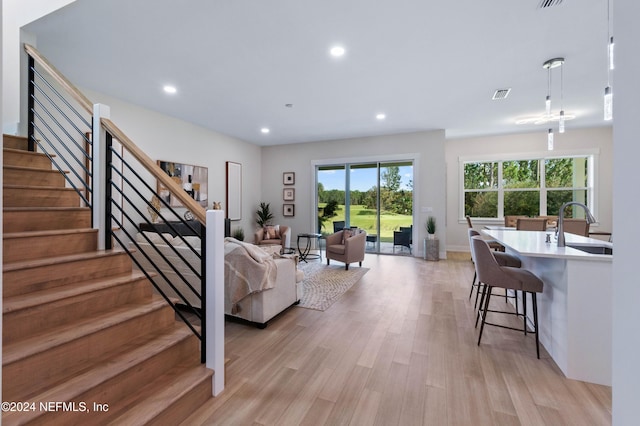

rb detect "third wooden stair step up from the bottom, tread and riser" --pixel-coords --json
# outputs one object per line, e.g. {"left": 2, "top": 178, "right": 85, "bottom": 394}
{"left": 2, "top": 298, "right": 175, "bottom": 401}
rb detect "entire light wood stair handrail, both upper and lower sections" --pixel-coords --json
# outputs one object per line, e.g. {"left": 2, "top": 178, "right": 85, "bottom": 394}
{"left": 24, "top": 43, "right": 207, "bottom": 225}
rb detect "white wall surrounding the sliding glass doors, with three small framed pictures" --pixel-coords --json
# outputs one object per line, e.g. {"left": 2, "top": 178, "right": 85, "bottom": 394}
{"left": 254, "top": 130, "right": 446, "bottom": 258}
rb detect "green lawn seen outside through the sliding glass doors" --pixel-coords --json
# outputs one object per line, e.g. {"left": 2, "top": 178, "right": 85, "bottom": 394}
{"left": 320, "top": 204, "right": 413, "bottom": 242}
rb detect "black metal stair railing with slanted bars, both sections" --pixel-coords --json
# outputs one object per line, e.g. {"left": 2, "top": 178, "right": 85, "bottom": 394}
{"left": 25, "top": 46, "right": 206, "bottom": 363}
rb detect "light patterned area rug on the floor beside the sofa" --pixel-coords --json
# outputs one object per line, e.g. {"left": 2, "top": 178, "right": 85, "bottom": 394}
{"left": 298, "top": 262, "right": 369, "bottom": 311}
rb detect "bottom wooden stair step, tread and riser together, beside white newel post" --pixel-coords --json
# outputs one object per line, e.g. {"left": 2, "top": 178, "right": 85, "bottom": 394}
{"left": 106, "top": 365, "right": 213, "bottom": 425}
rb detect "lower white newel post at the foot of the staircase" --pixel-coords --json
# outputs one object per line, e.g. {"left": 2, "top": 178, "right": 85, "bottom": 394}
{"left": 204, "top": 210, "right": 225, "bottom": 396}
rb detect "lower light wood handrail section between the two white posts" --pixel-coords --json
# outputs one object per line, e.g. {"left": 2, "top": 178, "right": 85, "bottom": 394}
{"left": 100, "top": 118, "right": 207, "bottom": 225}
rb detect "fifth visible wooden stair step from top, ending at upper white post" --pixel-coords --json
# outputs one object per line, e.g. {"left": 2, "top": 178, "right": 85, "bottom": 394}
{"left": 3, "top": 207, "right": 91, "bottom": 232}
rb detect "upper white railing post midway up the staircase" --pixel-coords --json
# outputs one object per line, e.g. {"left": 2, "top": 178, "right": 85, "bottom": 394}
{"left": 92, "top": 104, "right": 111, "bottom": 250}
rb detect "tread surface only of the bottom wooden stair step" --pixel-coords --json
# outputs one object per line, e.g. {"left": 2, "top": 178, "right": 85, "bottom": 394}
{"left": 110, "top": 365, "right": 213, "bottom": 425}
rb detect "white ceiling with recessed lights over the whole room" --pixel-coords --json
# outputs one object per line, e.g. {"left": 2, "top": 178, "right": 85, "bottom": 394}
{"left": 26, "top": 0, "right": 607, "bottom": 145}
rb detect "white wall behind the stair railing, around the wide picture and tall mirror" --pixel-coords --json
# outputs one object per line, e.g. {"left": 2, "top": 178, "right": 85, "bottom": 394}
{"left": 81, "top": 89, "right": 262, "bottom": 234}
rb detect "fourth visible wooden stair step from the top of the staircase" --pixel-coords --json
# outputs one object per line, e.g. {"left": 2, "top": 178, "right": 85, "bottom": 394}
{"left": 2, "top": 185, "right": 80, "bottom": 207}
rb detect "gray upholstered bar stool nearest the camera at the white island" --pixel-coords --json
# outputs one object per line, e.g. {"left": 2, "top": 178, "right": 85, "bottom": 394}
{"left": 471, "top": 236, "right": 543, "bottom": 358}
